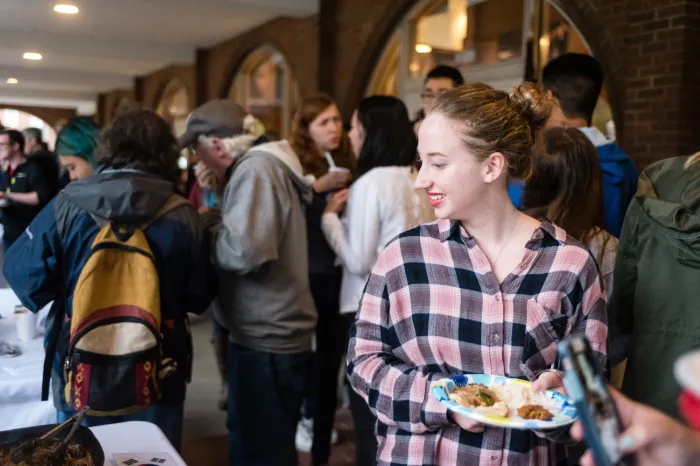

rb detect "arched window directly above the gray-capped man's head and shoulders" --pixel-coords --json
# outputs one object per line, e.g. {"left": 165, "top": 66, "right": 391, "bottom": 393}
{"left": 228, "top": 45, "right": 300, "bottom": 138}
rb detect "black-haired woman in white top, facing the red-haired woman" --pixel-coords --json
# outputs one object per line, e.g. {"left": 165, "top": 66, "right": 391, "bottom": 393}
{"left": 323, "top": 96, "right": 434, "bottom": 466}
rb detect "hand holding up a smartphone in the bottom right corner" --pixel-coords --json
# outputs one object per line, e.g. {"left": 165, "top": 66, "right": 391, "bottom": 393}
{"left": 571, "top": 387, "right": 700, "bottom": 466}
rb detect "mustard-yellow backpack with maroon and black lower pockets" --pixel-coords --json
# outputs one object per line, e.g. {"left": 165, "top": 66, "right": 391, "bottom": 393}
{"left": 63, "top": 195, "right": 188, "bottom": 416}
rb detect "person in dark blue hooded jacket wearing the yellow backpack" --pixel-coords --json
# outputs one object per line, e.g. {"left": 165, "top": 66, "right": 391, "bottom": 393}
{"left": 3, "top": 110, "right": 216, "bottom": 450}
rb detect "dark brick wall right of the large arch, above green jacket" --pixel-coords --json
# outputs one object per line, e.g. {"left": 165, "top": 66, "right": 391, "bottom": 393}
{"left": 618, "top": 0, "right": 700, "bottom": 166}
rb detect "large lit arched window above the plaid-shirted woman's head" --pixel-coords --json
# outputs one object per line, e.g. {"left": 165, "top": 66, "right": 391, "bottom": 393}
{"left": 365, "top": 0, "right": 615, "bottom": 134}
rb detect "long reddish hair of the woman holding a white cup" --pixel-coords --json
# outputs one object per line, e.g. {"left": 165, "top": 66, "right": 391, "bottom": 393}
{"left": 289, "top": 94, "right": 357, "bottom": 178}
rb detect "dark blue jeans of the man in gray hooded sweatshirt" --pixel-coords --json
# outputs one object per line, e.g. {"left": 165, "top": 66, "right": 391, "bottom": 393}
{"left": 226, "top": 343, "right": 311, "bottom": 466}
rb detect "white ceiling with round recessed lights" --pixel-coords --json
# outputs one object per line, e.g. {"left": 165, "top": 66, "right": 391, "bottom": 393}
{"left": 0, "top": 0, "right": 319, "bottom": 113}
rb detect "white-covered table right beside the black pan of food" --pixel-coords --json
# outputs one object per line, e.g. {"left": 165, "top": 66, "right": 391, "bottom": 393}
{"left": 90, "top": 421, "right": 187, "bottom": 466}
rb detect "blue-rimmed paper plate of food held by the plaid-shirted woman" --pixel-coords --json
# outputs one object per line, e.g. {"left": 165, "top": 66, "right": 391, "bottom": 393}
{"left": 430, "top": 374, "right": 578, "bottom": 430}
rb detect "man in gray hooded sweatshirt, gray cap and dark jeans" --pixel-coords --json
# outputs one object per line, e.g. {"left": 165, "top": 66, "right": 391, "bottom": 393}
{"left": 180, "top": 100, "right": 317, "bottom": 466}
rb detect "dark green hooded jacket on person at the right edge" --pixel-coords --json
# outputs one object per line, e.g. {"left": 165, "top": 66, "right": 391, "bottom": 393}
{"left": 609, "top": 157, "right": 700, "bottom": 418}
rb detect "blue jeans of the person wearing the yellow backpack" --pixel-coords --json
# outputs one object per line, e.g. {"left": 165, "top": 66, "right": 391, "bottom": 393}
{"left": 57, "top": 403, "right": 185, "bottom": 452}
